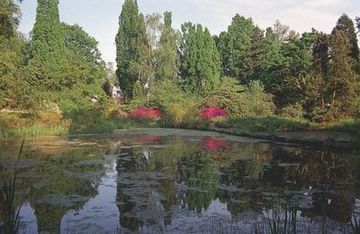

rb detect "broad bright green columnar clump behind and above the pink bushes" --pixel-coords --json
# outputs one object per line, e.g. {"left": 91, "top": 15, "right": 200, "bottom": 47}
{"left": 180, "top": 23, "right": 220, "bottom": 95}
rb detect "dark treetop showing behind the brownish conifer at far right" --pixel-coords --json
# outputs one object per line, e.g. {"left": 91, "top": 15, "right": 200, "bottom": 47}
{"left": 332, "top": 14, "right": 359, "bottom": 61}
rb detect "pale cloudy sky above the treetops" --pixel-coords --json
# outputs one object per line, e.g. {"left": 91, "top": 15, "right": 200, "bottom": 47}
{"left": 19, "top": 0, "right": 360, "bottom": 62}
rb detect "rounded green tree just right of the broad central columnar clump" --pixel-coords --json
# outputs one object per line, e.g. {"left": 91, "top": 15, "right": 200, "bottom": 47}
{"left": 217, "top": 14, "right": 255, "bottom": 83}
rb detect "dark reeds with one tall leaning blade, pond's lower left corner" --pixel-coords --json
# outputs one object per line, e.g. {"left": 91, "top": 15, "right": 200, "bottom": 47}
{"left": 0, "top": 140, "right": 25, "bottom": 233}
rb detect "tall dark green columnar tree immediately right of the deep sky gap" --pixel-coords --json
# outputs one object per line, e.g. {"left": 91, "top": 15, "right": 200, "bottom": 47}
{"left": 115, "top": 0, "right": 152, "bottom": 100}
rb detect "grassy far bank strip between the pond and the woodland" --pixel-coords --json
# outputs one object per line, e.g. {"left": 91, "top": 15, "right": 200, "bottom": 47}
{"left": 0, "top": 110, "right": 360, "bottom": 137}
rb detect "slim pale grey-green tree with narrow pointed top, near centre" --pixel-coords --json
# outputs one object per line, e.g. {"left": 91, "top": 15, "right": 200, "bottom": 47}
{"left": 156, "top": 12, "right": 179, "bottom": 80}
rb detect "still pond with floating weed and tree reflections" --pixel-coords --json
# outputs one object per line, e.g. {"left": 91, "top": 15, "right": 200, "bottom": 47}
{"left": 0, "top": 129, "right": 360, "bottom": 233}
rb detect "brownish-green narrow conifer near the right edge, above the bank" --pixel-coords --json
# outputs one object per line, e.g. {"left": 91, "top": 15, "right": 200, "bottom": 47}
{"left": 327, "top": 29, "right": 356, "bottom": 119}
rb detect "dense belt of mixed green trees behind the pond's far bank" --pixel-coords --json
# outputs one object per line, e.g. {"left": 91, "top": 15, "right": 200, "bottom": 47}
{"left": 0, "top": 0, "right": 360, "bottom": 133}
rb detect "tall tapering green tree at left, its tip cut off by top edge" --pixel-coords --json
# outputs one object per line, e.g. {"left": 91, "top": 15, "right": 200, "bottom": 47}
{"left": 25, "top": 0, "right": 66, "bottom": 91}
